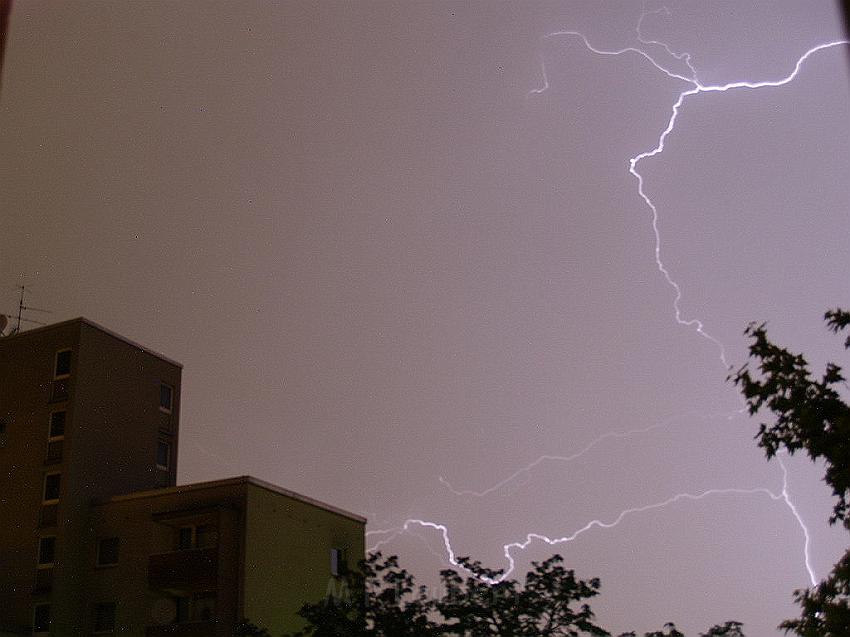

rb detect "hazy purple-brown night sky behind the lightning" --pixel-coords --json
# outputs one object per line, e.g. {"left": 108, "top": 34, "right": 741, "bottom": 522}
{"left": 0, "top": 0, "right": 850, "bottom": 637}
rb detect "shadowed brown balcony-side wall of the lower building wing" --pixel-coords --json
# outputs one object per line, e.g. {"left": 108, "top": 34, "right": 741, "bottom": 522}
{"left": 87, "top": 482, "right": 245, "bottom": 637}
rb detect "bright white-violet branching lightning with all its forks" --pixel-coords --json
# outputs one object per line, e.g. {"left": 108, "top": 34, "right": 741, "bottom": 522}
{"left": 366, "top": 8, "right": 850, "bottom": 586}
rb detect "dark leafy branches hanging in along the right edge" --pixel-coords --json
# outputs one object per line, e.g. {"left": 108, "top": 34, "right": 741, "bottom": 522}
{"left": 730, "top": 309, "right": 850, "bottom": 637}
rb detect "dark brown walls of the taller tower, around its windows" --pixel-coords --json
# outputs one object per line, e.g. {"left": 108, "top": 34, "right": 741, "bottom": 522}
{"left": 0, "top": 319, "right": 181, "bottom": 635}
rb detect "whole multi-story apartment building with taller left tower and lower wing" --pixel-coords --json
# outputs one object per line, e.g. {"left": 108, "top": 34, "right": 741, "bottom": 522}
{"left": 0, "top": 319, "right": 365, "bottom": 637}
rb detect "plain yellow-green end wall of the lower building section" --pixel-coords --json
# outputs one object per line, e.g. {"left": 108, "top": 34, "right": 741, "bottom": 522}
{"left": 242, "top": 484, "right": 365, "bottom": 635}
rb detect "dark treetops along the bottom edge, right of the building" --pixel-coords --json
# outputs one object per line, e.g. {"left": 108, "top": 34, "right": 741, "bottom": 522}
{"left": 284, "top": 553, "right": 744, "bottom": 637}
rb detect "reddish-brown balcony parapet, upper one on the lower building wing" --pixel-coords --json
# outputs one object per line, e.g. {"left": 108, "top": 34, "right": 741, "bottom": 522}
{"left": 148, "top": 547, "right": 218, "bottom": 592}
